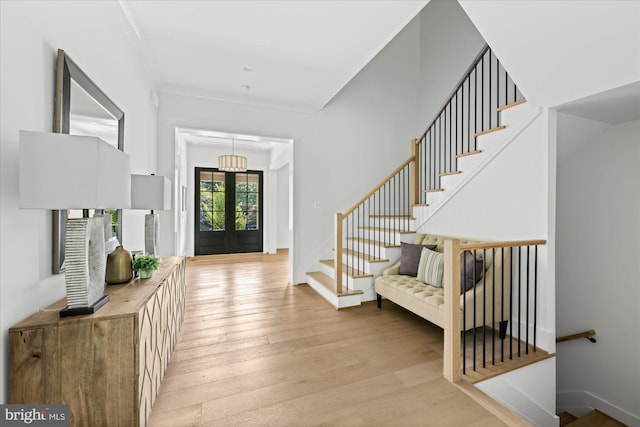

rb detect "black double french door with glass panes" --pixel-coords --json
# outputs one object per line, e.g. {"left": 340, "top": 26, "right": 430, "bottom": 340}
{"left": 194, "top": 168, "right": 263, "bottom": 255}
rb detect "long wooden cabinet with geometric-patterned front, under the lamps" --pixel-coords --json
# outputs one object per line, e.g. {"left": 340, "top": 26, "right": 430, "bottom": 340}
{"left": 9, "top": 257, "right": 186, "bottom": 427}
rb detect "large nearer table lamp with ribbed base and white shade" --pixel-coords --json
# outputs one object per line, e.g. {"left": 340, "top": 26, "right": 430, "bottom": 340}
{"left": 20, "top": 131, "right": 131, "bottom": 317}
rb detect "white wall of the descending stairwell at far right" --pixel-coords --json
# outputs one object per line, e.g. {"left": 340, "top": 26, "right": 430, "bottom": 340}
{"left": 556, "top": 114, "right": 640, "bottom": 425}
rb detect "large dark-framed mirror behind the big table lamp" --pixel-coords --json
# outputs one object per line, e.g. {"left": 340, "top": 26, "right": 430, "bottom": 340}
{"left": 53, "top": 49, "right": 124, "bottom": 273}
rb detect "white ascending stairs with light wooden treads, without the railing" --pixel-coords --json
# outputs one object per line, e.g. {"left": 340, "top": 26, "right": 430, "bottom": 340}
{"left": 307, "top": 100, "right": 538, "bottom": 309}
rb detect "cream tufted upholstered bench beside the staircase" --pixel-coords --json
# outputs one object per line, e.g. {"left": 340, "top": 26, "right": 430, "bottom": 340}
{"left": 375, "top": 234, "right": 511, "bottom": 337}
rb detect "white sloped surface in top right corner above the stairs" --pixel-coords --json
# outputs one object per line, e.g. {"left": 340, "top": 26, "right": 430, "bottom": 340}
{"left": 458, "top": 0, "right": 640, "bottom": 107}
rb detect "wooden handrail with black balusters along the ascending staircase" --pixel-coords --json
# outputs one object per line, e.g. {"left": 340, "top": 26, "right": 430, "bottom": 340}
{"left": 334, "top": 45, "right": 524, "bottom": 293}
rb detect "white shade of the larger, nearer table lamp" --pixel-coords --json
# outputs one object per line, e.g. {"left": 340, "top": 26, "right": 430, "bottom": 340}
{"left": 20, "top": 131, "right": 131, "bottom": 209}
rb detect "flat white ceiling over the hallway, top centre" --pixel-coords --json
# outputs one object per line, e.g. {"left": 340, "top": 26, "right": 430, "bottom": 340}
{"left": 120, "top": 0, "right": 429, "bottom": 110}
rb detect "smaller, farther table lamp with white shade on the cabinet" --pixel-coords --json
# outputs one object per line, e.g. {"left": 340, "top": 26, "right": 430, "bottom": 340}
{"left": 131, "top": 174, "right": 171, "bottom": 256}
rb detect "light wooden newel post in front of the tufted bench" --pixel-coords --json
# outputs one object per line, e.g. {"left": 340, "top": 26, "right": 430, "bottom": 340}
{"left": 443, "top": 239, "right": 462, "bottom": 382}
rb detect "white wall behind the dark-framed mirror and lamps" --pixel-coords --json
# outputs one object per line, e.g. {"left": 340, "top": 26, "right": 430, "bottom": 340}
{"left": 0, "top": 1, "right": 157, "bottom": 403}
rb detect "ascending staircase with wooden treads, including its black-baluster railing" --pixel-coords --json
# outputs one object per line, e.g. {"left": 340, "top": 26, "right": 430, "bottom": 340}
{"left": 307, "top": 46, "right": 539, "bottom": 309}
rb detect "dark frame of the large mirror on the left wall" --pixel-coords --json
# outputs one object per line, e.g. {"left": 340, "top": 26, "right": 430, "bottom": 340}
{"left": 52, "top": 49, "right": 124, "bottom": 274}
